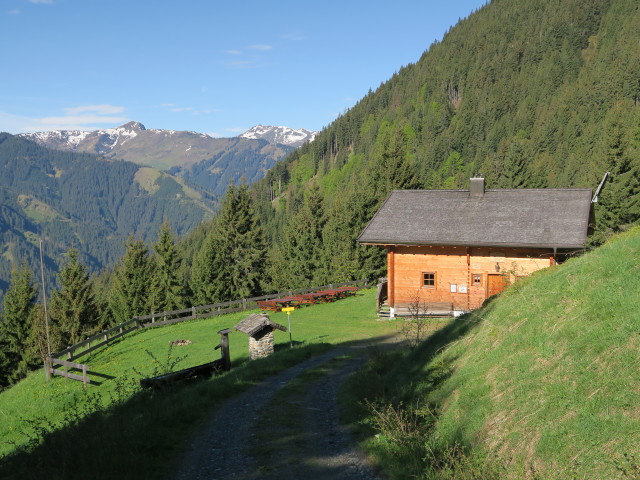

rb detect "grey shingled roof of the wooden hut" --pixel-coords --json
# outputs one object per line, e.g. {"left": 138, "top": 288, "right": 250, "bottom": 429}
{"left": 358, "top": 188, "right": 592, "bottom": 248}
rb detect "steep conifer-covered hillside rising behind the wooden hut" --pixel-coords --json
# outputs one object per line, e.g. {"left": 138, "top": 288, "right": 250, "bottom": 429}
{"left": 235, "top": 0, "right": 640, "bottom": 287}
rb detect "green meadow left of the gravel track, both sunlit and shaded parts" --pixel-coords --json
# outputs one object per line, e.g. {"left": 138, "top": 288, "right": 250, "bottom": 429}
{"left": 0, "top": 290, "right": 396, "bottom": 480}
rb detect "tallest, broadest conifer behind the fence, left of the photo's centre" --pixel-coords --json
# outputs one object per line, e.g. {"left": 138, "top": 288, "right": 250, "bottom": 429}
{"left": 192, "top": 184, "right": 266, "bottom": 304}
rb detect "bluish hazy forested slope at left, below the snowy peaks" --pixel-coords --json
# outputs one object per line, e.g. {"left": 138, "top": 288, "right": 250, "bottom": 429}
{"left": 0, "top": 133, "right": 214, "bottom": 302}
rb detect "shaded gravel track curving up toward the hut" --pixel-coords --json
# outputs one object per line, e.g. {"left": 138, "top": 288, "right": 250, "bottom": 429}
{"left": 170, "top": 347, "right": 379, "bottom": 480}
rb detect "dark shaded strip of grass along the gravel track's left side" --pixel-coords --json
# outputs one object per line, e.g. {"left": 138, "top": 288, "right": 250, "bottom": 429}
{"left": 0, "top": 343, "right": 333, "bottom": 480}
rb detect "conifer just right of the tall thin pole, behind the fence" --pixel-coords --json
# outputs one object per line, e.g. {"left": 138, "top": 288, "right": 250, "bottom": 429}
{"left": 51, "top": 249, "right": 101, "bottom": 345}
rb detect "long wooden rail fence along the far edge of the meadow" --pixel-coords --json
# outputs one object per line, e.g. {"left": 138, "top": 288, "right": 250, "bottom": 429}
{"left": 45, "top": 279, "right": 368, "bottom": 383}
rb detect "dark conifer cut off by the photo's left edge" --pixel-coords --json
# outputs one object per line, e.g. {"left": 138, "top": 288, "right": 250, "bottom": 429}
{"left": 0, "top": 264, "right": 37, "bottom": 386}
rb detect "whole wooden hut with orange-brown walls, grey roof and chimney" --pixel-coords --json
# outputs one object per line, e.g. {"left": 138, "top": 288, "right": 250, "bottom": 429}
{"left": 358, "top": 178, "right": 593, "bottom": 317}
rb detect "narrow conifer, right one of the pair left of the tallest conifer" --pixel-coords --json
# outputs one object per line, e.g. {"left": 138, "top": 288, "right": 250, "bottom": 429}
{"left": 150, "top": 222, "right": 185, "bottom": 312}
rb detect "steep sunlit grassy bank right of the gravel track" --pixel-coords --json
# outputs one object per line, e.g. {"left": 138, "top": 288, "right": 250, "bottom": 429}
{"left": 344, "top": 228, "right": 640, "bottom": 479}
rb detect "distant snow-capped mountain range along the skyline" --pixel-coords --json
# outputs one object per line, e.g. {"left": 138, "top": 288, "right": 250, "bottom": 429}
{"left": 19, "top": 122, "right": 316, "bottom": 200}
